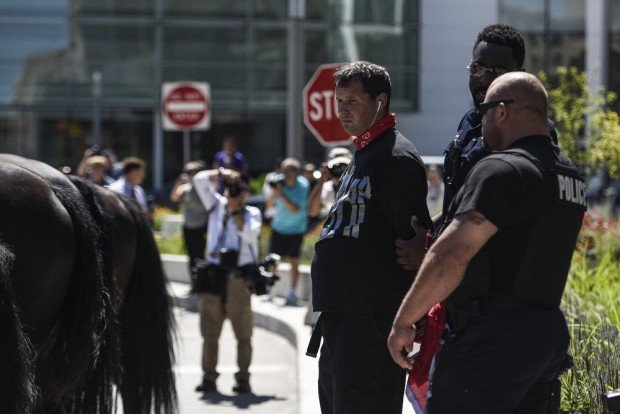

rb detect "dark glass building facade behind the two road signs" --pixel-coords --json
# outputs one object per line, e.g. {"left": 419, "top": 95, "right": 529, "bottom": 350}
{"left": 0, "top": 0, "right": 419, "bottom": 186}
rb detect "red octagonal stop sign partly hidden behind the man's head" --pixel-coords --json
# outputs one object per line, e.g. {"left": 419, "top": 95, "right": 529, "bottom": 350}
{"left": 303, "top": 64, "right": 351, "bottom": 146}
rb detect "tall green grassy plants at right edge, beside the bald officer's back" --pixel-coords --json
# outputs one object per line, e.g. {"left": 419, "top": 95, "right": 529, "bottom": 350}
{"left": 561, "top": 213, "right": 620, "bottom": 414}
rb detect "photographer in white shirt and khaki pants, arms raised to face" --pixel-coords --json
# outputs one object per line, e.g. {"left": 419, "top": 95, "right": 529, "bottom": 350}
{"left": 192, "top": 168, "right": 262, "bottom": 393}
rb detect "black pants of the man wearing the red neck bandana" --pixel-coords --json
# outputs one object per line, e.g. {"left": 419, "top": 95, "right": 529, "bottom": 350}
{"left": 319, "top": 313, "right": 405, "bottom": 414}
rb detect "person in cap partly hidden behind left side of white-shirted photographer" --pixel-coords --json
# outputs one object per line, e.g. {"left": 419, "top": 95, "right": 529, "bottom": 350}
{"left": 170, "top": 161, "right": 209, "bottom": 273}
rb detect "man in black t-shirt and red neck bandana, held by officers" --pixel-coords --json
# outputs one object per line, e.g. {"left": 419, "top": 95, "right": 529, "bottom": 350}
{"left": 308, "top": 62, "right": 432, "bottom": 414}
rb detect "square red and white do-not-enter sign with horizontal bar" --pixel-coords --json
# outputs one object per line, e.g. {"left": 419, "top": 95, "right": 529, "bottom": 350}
{"left": 161, "top": 82, "right": 211, "bottom": 131}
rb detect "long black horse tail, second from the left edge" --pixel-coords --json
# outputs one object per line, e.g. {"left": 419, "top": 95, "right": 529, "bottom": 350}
{"left": 43, "top": 185, "right": 114, "bottom": 413}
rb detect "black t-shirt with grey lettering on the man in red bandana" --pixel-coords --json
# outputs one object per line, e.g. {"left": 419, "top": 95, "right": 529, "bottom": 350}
{"left": 312, "top": 130, "right": 432, "bottom": 314}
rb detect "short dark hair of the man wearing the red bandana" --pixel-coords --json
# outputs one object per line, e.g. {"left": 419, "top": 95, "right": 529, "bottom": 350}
{"left": 334, "top": 60, "right": 392, "bottom": 110}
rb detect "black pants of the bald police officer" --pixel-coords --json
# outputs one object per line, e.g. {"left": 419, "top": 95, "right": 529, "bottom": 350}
{"left": 427, "top": 309, "right": 569, "bottom": 414}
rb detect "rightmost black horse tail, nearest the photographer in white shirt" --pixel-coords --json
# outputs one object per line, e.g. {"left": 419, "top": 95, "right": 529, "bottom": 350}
{"left": 120, "top": 200, "right": 178, "bottom": 414}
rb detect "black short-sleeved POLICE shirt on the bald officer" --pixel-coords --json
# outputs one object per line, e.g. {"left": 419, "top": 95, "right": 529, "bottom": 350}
{"left": 448, "top": 136, "right": 585, "bottom": 309}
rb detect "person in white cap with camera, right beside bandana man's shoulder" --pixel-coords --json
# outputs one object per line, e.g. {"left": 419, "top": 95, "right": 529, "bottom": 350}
{"left": 308, "top": 147, "right": 353, "bottom": 219}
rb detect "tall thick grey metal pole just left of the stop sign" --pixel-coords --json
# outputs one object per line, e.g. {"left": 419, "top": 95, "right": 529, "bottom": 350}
{"left": 286, "top": 0, "right": 306, "bottom": 160}
